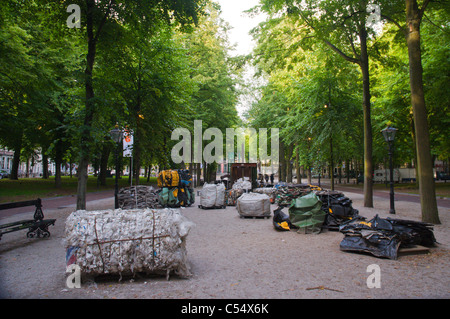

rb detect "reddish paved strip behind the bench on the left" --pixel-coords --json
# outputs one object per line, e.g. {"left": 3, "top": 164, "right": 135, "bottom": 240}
{"left": 0, "top": 190, "right": 114, "bottom": 219}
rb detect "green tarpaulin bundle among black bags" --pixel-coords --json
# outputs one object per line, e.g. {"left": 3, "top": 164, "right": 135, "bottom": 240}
{"left": 289, "top": 192, "right": 325, "bottom": 233}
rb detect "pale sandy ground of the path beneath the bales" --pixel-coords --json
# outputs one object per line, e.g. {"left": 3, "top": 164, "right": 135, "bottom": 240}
{"left": 0, "top": 192, "right": 450, "bottom": 299}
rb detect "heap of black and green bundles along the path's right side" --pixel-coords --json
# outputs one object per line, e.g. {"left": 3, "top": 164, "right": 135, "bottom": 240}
{"left": 273, "top": 190, "right": 436, "bottom": 259}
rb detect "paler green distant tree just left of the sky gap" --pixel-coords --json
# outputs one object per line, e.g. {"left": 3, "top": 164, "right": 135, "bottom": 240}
{"left": 182, "top": 3, "right": 240, "bottom": 181}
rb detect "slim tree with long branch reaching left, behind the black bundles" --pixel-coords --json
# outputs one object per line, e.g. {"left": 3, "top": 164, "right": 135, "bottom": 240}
{"left": 255, "top": 0, "right": 373, "bottom": 207}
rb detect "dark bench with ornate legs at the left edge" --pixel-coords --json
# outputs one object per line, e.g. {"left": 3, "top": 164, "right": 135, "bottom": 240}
{"left": 0, "top": 198, "right": 56, "bottom": 240}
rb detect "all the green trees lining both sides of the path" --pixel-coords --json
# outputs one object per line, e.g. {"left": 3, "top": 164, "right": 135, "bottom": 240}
{"left": 0, "top": 0, "right": 450, "bottom": 222}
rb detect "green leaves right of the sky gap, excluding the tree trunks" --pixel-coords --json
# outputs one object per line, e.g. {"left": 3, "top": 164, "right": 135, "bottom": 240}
{"left": 248, "top": 0, "right": 450, "bottom": 178}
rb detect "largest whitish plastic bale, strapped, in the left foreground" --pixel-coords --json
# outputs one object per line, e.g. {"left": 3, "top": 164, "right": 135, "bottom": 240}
{"left": 65, "top": 209, "right": 194, "bottom": 278}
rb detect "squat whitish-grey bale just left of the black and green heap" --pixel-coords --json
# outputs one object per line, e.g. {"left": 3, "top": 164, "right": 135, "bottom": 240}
{"left": 236, "top": 193, "right": 270, "bottom": 217}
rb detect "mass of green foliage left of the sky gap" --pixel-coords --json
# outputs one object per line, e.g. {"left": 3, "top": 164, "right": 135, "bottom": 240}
{"left": 0, "top": 0, "right": 243, "bottom": 185}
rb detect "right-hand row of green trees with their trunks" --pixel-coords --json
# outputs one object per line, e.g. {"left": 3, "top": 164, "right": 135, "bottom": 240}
{"left": 248, "top": 0, "right": 449, "bottom": 222}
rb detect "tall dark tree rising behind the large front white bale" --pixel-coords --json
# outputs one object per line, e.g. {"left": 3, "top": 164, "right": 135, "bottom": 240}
{"left": 60, "top": 0, "right": 205, "bottom": 209}
